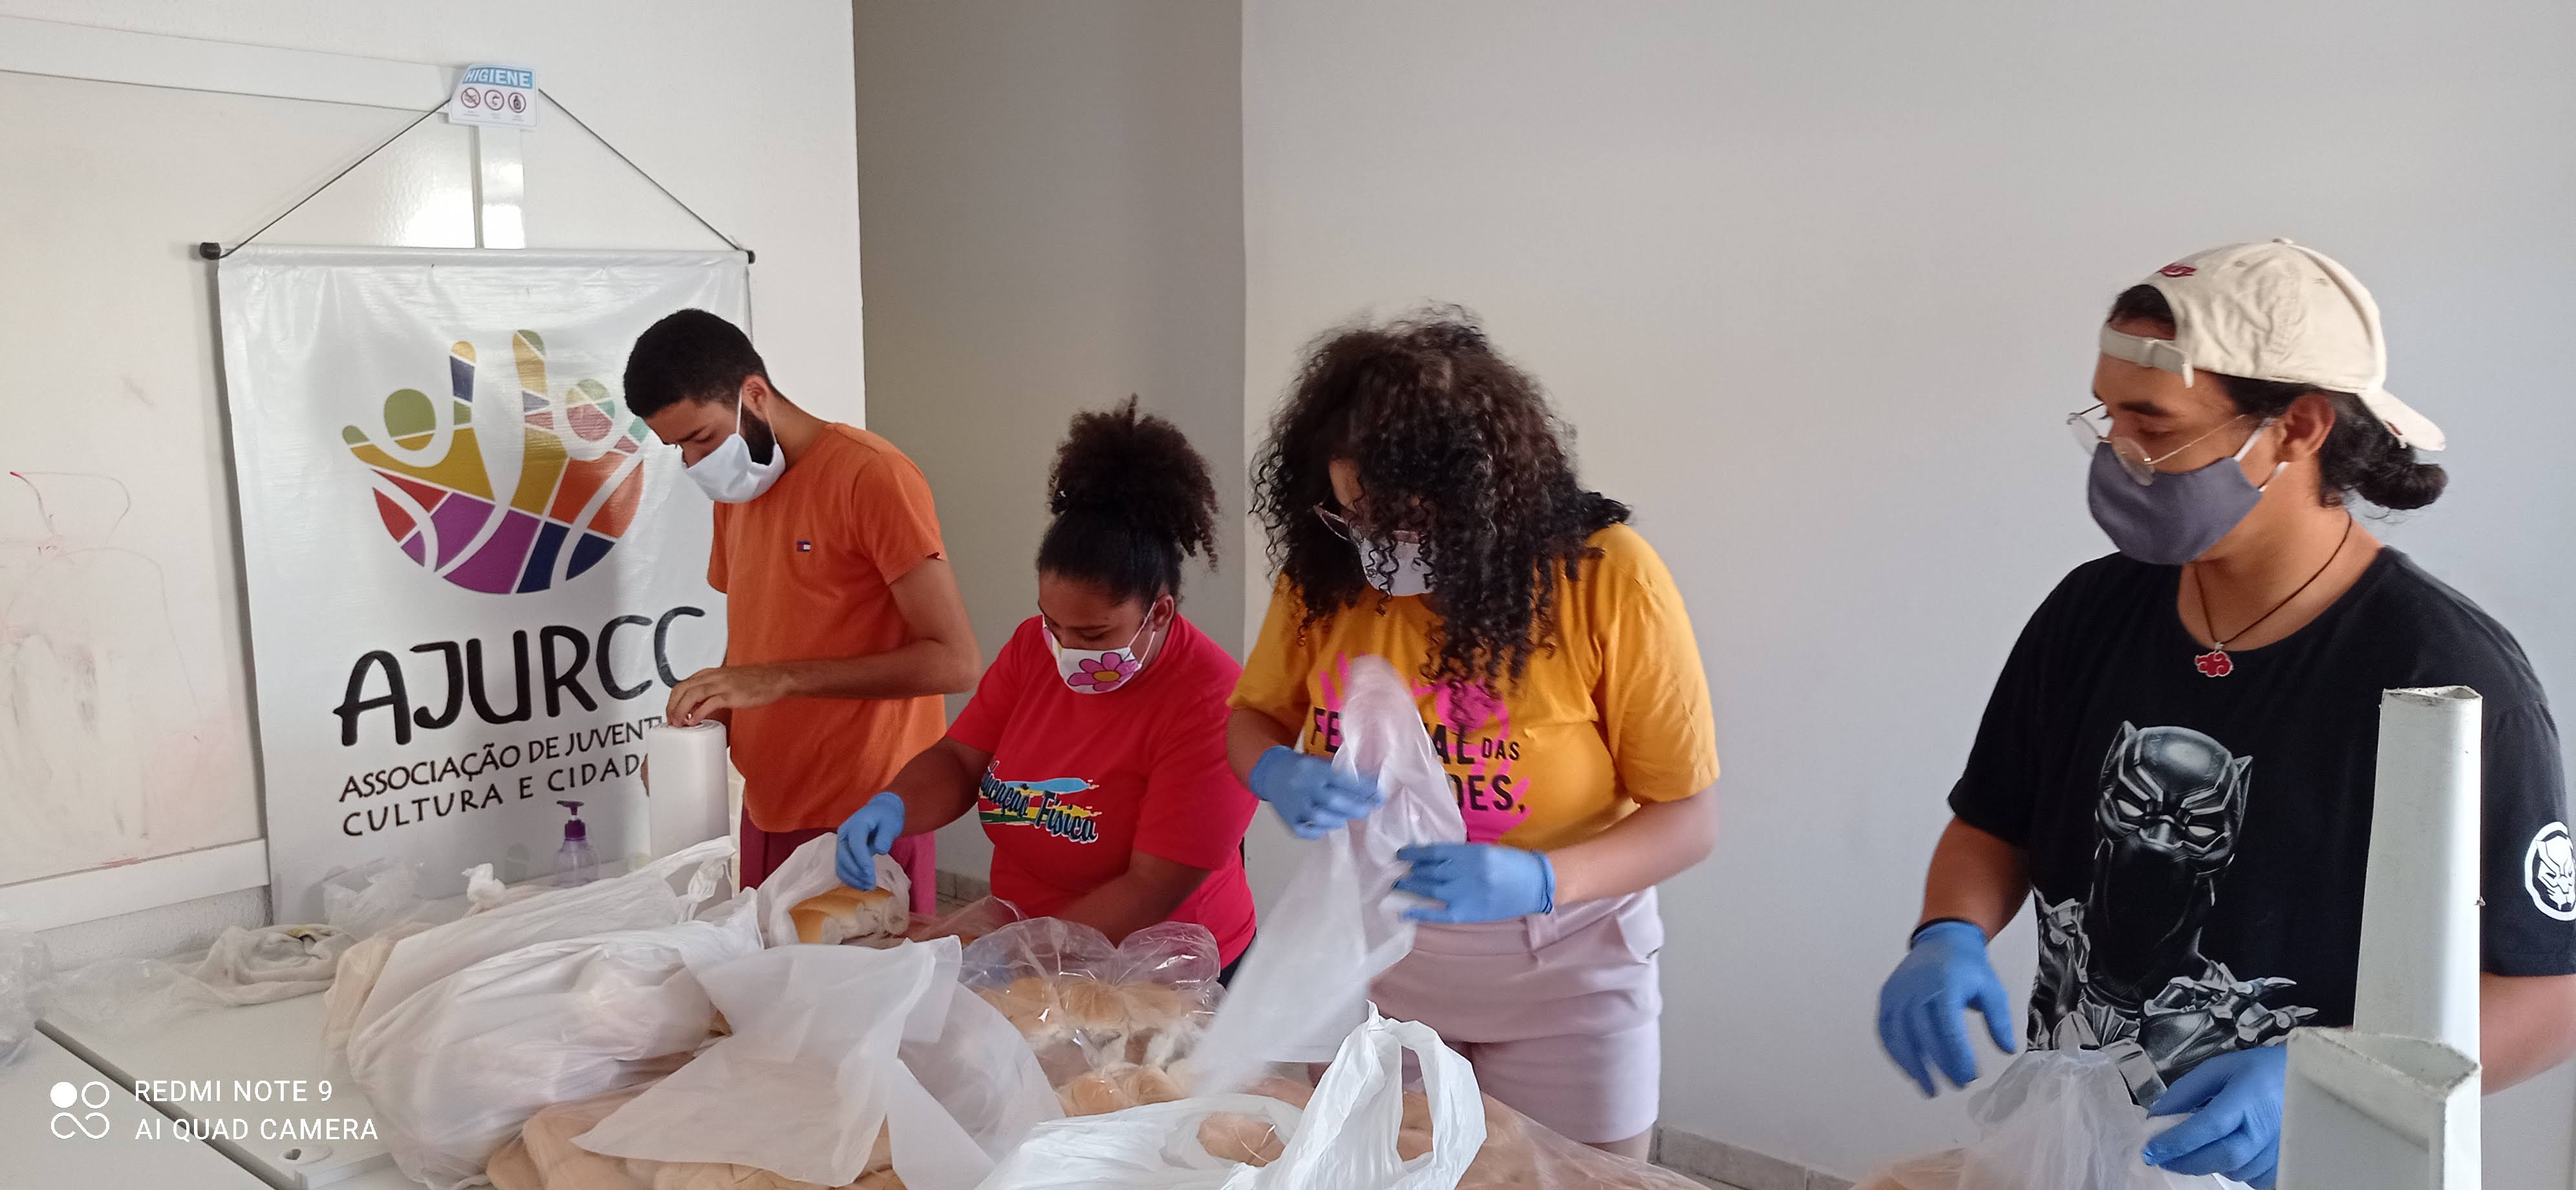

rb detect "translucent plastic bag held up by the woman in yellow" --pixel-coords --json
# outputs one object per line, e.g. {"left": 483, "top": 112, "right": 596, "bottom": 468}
{"left": 1196, "top": 657, "right": 1466, "bottom": 1092}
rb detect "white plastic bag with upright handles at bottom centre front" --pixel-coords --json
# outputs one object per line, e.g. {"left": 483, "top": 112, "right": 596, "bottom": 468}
{"left": 982, "top": 1012, "right": 1484, "bottom": 1190}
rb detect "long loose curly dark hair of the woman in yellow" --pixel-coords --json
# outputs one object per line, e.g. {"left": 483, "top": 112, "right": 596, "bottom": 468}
{"left": 1252, "top": 307, "right": 1628, "bottom": 693}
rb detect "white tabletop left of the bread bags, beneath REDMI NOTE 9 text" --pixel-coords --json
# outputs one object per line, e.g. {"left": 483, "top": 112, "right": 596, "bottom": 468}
{"left": 43, "top": 994, "right": 420, "bottom": 1190}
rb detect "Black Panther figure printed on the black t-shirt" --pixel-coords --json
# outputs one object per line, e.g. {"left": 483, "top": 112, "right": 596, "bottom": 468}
{"left": 2030, "top": 724, "right": 2316, "bottom": 1090}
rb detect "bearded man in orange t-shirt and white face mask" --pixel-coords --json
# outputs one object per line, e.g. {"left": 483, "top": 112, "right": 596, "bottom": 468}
{"left": 626, "top": 309, "right": 982, "bottom": 896}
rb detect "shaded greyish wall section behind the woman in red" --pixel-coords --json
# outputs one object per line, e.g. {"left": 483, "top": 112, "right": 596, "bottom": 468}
{"left": 855, "top": 0, "right": 1260, "bottom": 876}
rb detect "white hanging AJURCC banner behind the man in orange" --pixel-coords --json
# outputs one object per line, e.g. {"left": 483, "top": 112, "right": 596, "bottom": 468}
{"left": 217, "top": 244, "right": 749, "bottom": 922}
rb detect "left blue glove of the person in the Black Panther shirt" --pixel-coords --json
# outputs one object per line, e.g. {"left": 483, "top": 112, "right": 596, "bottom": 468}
{"left": 1878, "top": 922, "right": 2012, "bottom": 1095}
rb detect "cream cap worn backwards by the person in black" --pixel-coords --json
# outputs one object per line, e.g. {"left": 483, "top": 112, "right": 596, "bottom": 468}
{"left": 2102, "top": 239, "right": 2442, "bottom": 451}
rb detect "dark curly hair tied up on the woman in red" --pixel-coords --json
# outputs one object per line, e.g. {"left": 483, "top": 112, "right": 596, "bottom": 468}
{"left": 1038, "top": 396, "right": 1216, "bottom": 603}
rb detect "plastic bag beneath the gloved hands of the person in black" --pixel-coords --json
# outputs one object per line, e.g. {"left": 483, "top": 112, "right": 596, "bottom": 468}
{"left": 1862, "top": 1048, "right": 2244, "bottom": 1190}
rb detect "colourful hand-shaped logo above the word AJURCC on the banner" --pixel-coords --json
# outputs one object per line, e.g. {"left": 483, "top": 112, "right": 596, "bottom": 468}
{"left": 340, "top": 330, "right": 652, "bottom": 595}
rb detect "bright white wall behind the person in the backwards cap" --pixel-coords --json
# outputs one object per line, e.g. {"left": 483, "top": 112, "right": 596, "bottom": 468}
{"left": 1244, "top": 0, "right": 2576, "bottom": 1187}
